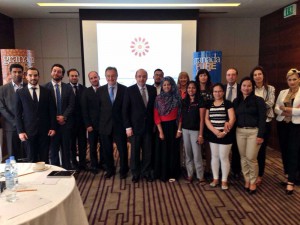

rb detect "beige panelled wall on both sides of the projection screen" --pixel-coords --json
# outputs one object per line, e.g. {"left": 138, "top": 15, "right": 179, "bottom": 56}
{"left": 14, "top": 18, "right": 260, "bottom": 84}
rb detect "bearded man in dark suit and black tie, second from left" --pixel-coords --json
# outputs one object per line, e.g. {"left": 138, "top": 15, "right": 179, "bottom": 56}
{"left": 15, "top": 67, "right": 56, "bottom": 163}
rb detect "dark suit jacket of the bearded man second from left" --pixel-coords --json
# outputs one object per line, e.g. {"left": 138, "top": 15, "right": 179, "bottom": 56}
{"left": 15, "top": 86, "right": 56, "bottom": 137}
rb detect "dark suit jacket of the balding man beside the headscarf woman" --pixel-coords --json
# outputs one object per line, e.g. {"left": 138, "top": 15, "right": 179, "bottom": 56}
{"left": 123, "top": 84, "right": 156, "bottom": 135}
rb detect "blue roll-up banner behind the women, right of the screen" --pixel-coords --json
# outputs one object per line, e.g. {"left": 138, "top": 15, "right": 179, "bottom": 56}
{"left": 193, "top": 51, "right": 222, "bottom": 83}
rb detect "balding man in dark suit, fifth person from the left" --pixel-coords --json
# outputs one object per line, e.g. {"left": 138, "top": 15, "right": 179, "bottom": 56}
{"left": 81, "top": 71, "right": 104, "bottom": 174}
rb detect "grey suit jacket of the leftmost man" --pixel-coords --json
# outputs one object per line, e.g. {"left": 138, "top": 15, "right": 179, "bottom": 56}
{"left": 0, "top": 82, "right": 27, "bottom": 131}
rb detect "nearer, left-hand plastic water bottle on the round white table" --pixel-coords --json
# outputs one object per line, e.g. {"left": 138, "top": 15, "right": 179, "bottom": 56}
{"left": 4, "top": 159, "right": 17, "bottom": 202}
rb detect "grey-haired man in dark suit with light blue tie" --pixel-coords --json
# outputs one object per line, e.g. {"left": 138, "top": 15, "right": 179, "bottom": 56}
{"left": 97, "top": 67, "right": 129, "bottom": 179}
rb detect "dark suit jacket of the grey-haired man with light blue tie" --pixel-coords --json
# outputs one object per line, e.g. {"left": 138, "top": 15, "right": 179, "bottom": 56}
{"left": 97, "top": 83, "right": 127, "bottom": 135}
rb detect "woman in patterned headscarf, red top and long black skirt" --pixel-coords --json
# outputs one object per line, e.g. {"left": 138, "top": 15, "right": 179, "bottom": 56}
{"left": 154, "top": 76, "right": 182, "bottom": 182}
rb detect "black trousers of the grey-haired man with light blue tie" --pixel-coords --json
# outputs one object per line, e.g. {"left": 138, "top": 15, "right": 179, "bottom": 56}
{"left": 100, "top": 131, "right": 129, "bottom": 174}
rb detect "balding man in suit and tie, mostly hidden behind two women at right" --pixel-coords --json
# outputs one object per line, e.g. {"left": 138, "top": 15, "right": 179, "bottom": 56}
{"left": 225, "top": 68, "right": 241, "bottom": 179}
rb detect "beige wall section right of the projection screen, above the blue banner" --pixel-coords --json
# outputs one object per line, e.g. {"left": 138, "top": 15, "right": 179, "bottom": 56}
{"left": 198, "top": 18, "right": 260, "bottom": 82}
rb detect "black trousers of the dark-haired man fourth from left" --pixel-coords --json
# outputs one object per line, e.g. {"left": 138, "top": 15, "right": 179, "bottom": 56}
{"left": 71, "top": 124, "right": 87, "bottom": 166}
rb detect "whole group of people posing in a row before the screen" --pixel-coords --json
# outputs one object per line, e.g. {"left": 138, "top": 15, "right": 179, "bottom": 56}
{"left": 0, "top": 64, "right": 300, "bottom": 195}
